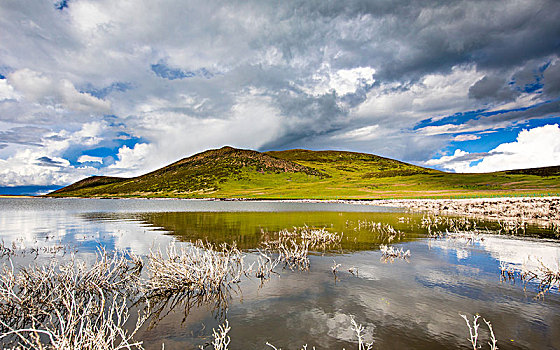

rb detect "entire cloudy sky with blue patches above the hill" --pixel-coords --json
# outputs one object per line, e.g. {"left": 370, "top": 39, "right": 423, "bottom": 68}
{"left": 0, "top": 0, "right": 560, "bottom": 193}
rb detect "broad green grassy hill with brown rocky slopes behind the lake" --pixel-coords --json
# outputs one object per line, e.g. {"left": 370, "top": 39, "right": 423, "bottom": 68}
{"left": 49, "top": 147, "right": 560, "bottom": 199}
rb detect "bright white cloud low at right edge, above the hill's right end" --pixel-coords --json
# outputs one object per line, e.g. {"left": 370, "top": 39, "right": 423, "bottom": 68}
{"left": 425, "top": 124, "right": 560, "bottom": 173}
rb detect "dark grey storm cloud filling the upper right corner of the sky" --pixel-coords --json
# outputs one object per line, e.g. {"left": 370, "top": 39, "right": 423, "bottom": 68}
{"left": 276, "top": 0, "right": 560, "bottom": 80}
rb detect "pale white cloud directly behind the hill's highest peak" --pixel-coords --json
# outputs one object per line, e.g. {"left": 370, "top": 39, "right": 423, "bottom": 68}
{"left": 110, "top": 89, "right": 285, "bottom": 172}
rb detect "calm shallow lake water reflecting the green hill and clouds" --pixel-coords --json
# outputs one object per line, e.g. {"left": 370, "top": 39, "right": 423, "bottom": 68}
{"left": 0, "top": 199, "right": 560, "bottom": 349}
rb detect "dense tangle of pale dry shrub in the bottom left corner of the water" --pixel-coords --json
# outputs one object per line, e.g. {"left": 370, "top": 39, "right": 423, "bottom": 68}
{"left": 0, "top": 250, "right": 147, "bottom": 349}
